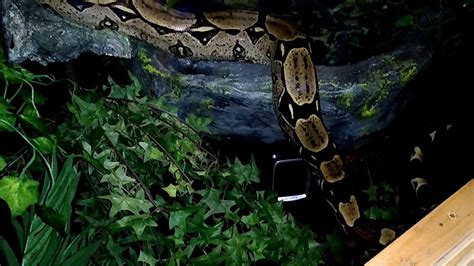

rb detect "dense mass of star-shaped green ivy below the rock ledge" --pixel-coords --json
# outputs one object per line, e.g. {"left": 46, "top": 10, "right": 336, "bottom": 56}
{"left": 62, "top": 74, "right": 321, "bottom": 265}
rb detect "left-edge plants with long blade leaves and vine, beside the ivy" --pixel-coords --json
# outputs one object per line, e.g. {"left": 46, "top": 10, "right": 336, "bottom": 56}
{"left": 0, "top": 48, "right": 81, "bottom": 265}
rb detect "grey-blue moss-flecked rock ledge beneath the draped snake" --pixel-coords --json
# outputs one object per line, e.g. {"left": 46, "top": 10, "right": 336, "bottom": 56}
{"left": 2, "top": 0, "right": 433, "bottom": 148}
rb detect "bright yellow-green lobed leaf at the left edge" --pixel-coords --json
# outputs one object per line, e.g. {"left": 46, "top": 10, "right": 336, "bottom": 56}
{"left": 0, "top": 176, "right": 39, "bottom": 216}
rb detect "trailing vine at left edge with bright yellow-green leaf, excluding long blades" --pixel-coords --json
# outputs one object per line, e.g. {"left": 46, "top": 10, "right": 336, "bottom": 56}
{"left": 0, "top": 48, "right": 56, "bottom": 218}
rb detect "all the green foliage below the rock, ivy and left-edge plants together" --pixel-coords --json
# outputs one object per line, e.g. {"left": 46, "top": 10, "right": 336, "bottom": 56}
{"left": 0, "top": 49, "right": 323, "bottom": 265}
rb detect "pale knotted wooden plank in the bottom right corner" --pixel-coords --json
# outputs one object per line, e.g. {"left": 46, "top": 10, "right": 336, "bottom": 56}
{"left": 365, "top": 179, "right": 474, "bottom": 266}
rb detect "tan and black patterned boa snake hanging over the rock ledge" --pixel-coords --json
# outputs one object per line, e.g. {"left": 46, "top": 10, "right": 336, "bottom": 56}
{"left": 37, "top": 0, "right": 395, "bottom": 245}
